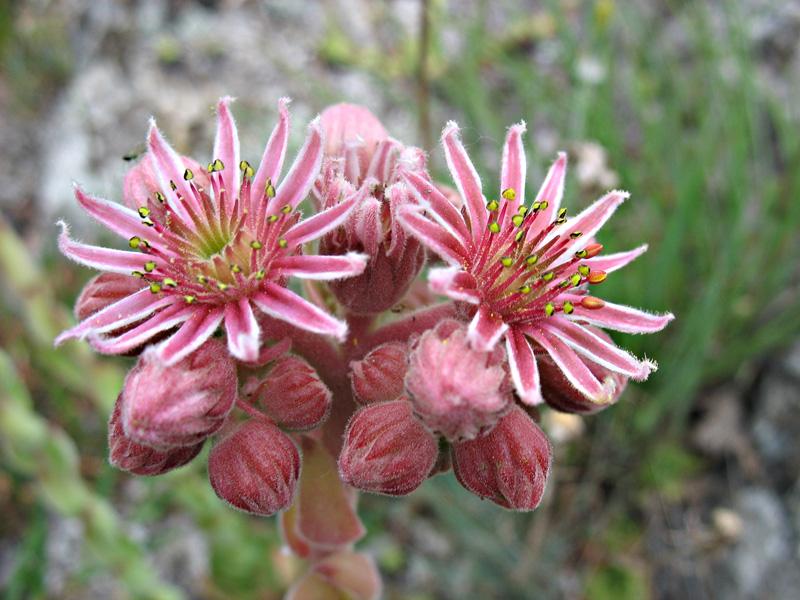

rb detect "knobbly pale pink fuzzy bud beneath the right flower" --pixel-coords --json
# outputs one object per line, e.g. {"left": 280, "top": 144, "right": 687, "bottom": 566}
{"left": 406, "top": 319, "right": 509, "bottom": 441}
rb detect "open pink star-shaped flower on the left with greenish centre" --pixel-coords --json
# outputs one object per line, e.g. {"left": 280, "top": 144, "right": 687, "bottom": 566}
{"left": 56, "top": 98, "right": 366, "bottom": 364}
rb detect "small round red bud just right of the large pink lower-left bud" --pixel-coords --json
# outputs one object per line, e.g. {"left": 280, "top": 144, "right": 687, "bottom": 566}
{"left": 254, "top": 356, "right": 332, "bottom": 430}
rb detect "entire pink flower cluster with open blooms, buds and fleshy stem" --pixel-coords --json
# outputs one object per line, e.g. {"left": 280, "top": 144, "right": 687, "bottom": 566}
{"left": 56, "top": 98, "right": 672, "bottom": 598}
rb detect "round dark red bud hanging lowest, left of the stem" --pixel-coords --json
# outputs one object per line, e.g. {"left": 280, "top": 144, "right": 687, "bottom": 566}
{"left": 208, "top": 419, "right": 300, "bottom": 516}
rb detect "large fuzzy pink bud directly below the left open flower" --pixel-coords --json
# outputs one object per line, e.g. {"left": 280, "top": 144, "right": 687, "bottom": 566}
{"left": 122, "top": 339, "right": 238, "bottom": 448}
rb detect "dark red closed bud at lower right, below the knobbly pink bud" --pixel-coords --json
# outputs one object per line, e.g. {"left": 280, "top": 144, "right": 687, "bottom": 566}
{"left": 453, "top": 406, "right": 552, "bottom": 510}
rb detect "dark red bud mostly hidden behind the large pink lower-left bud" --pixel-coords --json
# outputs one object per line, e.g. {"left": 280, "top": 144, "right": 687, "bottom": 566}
{"left": 108, "top": 394, "right": 203, "bottom": 475}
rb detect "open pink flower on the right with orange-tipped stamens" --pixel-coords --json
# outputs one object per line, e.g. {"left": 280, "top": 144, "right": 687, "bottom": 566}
{"left": 400, "top": 122, "right": 673, "bottom": 405}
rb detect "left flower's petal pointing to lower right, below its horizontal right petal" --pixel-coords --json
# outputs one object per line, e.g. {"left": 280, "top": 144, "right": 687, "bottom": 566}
{"left": 253, "top": 283, "right": 347, "bottom": 340}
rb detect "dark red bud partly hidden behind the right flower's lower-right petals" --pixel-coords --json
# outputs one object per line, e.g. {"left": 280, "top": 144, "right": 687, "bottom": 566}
{"left": 536, "top": 327, "right": 628, "bottom": 414}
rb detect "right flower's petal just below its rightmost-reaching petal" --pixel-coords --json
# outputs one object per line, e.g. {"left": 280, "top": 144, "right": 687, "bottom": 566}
{"left": 542, "top": 316, "right": 656, "bottom": 381}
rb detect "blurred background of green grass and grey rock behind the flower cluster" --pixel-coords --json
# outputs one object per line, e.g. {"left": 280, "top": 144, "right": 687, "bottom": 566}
{"left": 0, "top": 0, "right": 800, "bottom": 600}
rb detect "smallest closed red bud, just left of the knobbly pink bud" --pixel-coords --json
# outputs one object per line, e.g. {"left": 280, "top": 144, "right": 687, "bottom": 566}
{"left": 350, "top": 342, "right": 408, "bottom": 404}
